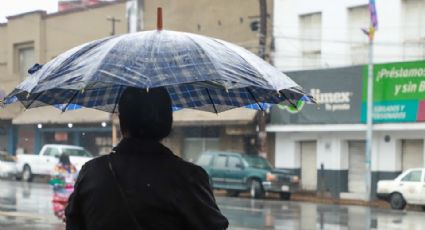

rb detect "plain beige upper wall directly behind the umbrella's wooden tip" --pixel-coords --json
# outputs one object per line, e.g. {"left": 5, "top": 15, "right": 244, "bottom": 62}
{"left": 143, "top": 0, "right": 273, "bottom": 53}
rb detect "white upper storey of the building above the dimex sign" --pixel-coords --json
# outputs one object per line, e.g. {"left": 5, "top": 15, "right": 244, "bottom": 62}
{"left": 273, "top": 0, "right": 425, "bottom": 71}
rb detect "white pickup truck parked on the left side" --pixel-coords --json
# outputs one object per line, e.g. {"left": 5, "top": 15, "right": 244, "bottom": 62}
{"left": 16, "top": 145, "right": 94, "bottom": 181}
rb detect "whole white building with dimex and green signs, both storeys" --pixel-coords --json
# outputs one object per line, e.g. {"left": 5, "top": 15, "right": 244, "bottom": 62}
{"left": 267, "top": 0, "right": 425, "bottom": 198}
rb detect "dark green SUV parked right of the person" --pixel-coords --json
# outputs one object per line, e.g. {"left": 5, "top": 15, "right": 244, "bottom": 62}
{"left": 196, "top": 152, "right": 299, "bottom": 200}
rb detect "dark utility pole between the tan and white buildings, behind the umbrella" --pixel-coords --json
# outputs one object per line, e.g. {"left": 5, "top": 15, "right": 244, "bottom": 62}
{"left": 257, "top": 0, "right": 267, "bottom": 158}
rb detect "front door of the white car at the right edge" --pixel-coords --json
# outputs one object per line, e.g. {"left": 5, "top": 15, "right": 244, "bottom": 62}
{"left": 398, "top": 169, "right": 423, "bottom": 204}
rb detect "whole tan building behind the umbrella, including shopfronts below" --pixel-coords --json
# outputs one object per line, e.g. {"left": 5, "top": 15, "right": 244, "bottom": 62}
{"left": 0, "top": 0, "right": 273, "bottom": 160}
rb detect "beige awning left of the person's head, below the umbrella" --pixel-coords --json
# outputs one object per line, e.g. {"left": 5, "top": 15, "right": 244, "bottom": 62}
{"left": 12, "top": 106, "right": 111, "bottom": 125}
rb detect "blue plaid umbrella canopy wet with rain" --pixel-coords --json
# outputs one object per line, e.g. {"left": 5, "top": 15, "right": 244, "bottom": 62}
{"left": 5, "top": 30, "right": 311, "bottom": 113}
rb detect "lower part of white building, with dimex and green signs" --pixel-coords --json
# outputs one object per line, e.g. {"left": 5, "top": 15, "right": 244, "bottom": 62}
{"left": 267, "top": 61, "right": 425, "bottom": 199}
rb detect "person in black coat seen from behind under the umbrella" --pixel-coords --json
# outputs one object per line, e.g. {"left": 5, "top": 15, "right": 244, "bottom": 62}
{"left": 66, "top": 87, "right": 228, "bottom": 230}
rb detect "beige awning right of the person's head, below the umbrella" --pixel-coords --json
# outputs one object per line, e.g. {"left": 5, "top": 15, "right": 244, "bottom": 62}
{"left": 173, "top": 108, "right": 257, "bottom": 126}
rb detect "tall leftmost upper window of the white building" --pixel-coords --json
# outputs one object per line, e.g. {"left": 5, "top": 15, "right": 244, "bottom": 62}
{"left": 300, "top": 13, "right": 322, "bottom": 68}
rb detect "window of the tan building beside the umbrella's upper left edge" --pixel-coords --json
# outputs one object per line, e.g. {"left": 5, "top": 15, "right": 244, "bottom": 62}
{"left": 15, "top": 43, "right": 35, "bottom": 80}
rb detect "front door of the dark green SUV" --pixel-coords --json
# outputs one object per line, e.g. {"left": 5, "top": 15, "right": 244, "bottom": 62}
{"left": 226, "top": 156, "right": 245, "bottom": 189}
